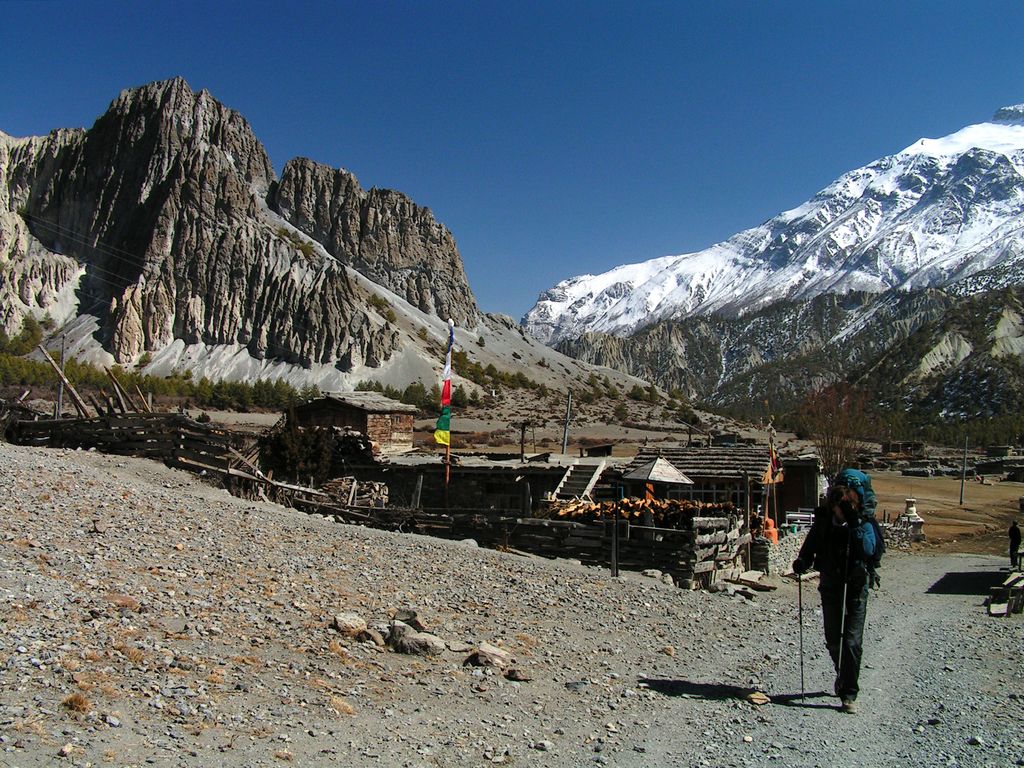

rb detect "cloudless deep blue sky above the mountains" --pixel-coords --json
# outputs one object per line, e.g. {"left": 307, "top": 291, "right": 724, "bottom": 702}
{"left": 0, "top": 0, "right": 1024, "bottom": 318}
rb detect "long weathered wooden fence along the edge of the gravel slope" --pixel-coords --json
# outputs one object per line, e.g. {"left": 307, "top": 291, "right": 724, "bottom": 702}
{"left": 8, "top": 413, "right": 750, "bottom": 587}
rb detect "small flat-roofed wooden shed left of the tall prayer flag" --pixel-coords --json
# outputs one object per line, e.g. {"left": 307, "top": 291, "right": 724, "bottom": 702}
{"left": 293, "top": 392, "right": 417, "bottom": 454}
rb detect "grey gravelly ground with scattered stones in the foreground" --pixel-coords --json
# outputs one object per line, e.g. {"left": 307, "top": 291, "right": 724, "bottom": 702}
{"left": 0, "top": 443, "right": 1024, "bottom": 768}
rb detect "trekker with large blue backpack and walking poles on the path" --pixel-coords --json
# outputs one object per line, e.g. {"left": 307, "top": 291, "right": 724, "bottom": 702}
{"left": 793, "top": 469, "right": 882, "bottom": 713}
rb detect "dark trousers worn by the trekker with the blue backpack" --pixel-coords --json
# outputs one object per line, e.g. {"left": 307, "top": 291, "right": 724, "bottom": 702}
{"left": 818, "top": 579, "right": 867, "bottom": 698}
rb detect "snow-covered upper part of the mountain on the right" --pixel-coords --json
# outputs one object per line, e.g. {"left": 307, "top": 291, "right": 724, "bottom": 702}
{"left": 522, "top": 104, "right": 1024, "bottom": 344}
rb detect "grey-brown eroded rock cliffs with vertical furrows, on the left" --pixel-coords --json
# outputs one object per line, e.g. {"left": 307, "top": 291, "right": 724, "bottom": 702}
{"left": 0, "top": 79, "right": 477, "bottom": 370}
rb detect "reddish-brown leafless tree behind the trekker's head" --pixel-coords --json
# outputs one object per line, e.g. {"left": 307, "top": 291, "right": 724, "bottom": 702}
{"left": 800, "top": 382, "right": 867, "bottom": 477}
